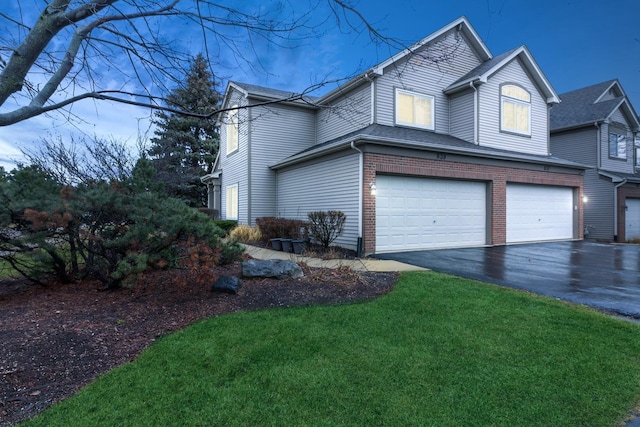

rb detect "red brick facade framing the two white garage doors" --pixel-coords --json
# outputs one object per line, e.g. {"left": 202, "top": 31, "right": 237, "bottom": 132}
{"left": 363, "top": 153, "right": 583, "bottom": 253}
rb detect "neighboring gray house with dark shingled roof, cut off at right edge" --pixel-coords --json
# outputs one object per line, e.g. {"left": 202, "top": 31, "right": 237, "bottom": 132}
{"left": 551, "top": 80, "right": 640, "bottom": 242}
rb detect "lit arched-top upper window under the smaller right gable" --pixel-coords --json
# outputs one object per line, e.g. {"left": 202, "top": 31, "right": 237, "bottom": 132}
{"left": 500, "top": 85, "right": 531, "bottom": 135}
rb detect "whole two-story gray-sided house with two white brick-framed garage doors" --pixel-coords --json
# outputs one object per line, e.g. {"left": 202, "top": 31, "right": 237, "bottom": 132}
{"left": 203, "top": 17, "right": 585, "bottom": 254}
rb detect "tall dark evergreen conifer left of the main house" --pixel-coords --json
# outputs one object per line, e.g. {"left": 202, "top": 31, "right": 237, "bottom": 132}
{"left": 149, "top": 54, "right": 222, "bottom": 207}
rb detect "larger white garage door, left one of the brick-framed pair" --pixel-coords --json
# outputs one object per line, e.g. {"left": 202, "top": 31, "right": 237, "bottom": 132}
{"left": 376, "top": 175, "right": 487, "bottom": 252}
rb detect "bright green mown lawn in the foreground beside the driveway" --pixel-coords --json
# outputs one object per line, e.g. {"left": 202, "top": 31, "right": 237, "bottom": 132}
{"left": 22, "top": 272, "right": 640, "bottom": 427}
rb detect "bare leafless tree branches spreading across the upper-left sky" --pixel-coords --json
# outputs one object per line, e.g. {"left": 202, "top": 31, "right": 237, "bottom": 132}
{"left": 0, "top": 0, "right": 396, "bottom": 126}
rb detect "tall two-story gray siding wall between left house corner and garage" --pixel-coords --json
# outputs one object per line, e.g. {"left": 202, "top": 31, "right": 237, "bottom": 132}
{"left": 249, "top": 104, "right": 315, "bottom": 225}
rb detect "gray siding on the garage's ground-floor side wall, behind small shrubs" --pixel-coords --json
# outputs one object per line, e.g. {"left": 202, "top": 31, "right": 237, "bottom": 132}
{"left": 277, "top": 152, "right": 360, "bottom": 249}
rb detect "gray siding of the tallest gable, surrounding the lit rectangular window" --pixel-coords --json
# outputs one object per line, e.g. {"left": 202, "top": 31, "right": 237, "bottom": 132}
{"left": 376, "top": 31, "right": 480, "bottom": 133}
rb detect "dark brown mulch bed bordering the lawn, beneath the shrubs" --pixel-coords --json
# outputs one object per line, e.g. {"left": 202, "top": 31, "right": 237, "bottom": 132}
{"left": 0, "top": 263, "right": 397, "bottom": 426}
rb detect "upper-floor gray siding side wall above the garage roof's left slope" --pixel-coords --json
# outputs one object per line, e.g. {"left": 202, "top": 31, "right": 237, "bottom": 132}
{"left": 317, "top": 82, "right": 372, "bottom": 144}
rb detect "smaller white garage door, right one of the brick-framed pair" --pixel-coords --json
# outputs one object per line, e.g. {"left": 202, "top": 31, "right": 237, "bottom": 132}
{"left": 507, "top": 184, "right": 573, "bottom": 243}
